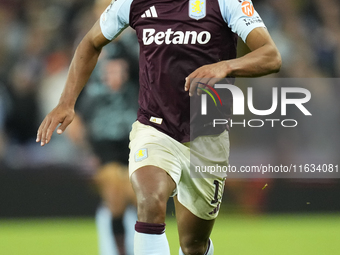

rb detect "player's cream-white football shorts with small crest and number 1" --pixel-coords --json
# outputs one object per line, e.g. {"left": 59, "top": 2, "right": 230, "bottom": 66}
{"left": 129, "top": 121, "right": 229, "bottom": 220}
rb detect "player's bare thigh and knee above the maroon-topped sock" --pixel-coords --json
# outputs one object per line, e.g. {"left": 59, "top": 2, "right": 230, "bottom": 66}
{"left": 130, "top": 165, "right": 176, "bottom": 223}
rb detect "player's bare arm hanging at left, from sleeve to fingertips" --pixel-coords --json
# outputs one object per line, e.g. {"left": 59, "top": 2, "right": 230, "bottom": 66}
{"left": 36, "top": 21, "right": 110, "bottom": 146}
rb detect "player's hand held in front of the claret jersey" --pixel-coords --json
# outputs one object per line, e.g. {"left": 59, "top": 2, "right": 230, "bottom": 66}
{"left": 184, "top": 61, "right": 229, "bottom": 96}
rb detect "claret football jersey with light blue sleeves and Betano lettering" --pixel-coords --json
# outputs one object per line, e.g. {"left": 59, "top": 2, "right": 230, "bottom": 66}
{"left": 100, "top": 0, "right": 264, "bottom": 142}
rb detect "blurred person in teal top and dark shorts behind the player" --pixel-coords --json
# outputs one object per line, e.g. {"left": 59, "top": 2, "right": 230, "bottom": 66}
{"left": 68, "top": 41, "right": 138, "bottom": 255}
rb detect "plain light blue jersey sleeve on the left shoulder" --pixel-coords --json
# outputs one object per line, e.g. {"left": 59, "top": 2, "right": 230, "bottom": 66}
{"left": 100, "top": 0, "right": 132, "bottom": 40}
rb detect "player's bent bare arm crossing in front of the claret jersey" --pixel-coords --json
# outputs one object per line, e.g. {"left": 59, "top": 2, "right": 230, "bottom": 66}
{"left": 184, "top": 27, "right": 281, "bottom": 95}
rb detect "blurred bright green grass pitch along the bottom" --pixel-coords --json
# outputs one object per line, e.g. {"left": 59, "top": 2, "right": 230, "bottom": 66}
{"left": 0, "top": 214, "right": 340, "bottom": 255}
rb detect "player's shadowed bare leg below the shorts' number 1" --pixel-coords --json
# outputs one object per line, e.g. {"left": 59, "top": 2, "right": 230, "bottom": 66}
{"left": 174, "top": 196, "right": 215, "bottom": 251}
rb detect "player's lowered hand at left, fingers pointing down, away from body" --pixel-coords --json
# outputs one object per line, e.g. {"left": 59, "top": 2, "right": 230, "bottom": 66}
{"left": 36, "top": 104, "right": 75, "bottom": 146}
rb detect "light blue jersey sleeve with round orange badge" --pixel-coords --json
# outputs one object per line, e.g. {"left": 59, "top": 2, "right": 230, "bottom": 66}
{"left": 218, "top": 0, "right": 266, "bottom": 42}
